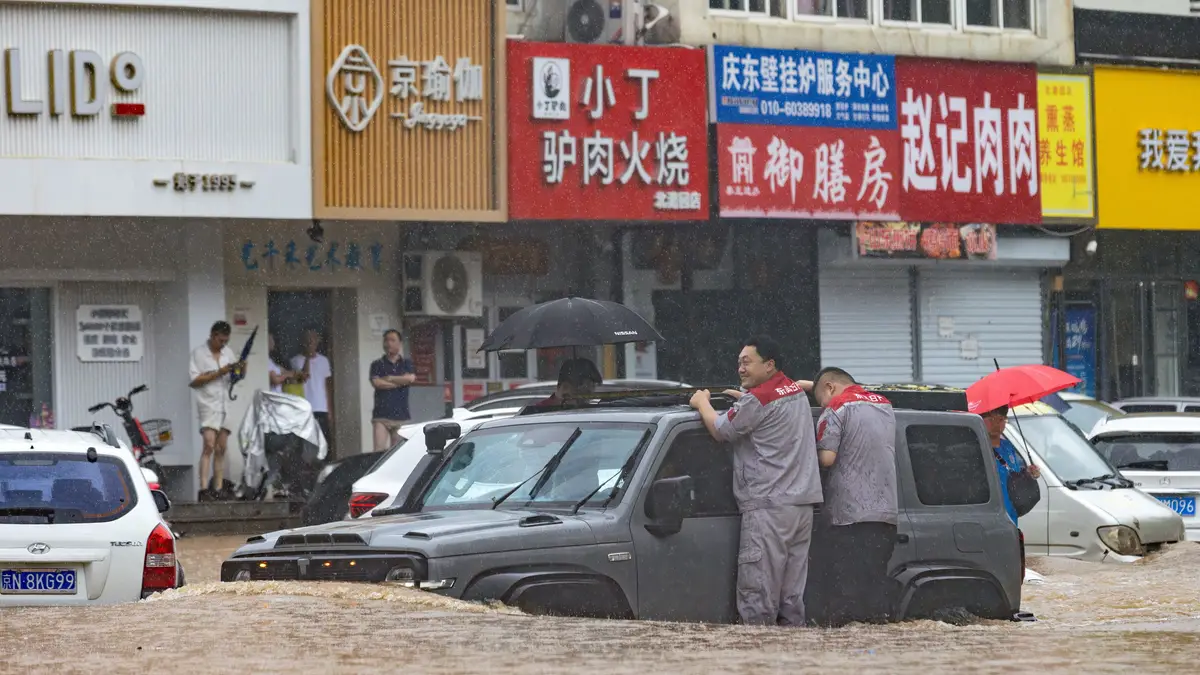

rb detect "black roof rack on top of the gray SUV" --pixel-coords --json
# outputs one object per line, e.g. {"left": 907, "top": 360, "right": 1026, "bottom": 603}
{"left": 517, "top": 383, "right": 967, "bottom": 416}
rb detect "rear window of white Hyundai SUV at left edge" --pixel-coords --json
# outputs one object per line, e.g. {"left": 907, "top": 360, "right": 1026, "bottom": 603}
{"left": 0, "top": 453, "right": 138, "bottom": 525}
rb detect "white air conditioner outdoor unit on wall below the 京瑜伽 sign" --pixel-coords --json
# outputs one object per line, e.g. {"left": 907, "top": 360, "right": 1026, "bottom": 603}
{"left": 402, "top": 251, "right": 484, "bottom": 317}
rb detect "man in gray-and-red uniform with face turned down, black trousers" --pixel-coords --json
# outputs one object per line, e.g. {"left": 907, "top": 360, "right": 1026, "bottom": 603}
{"left": 800, "top": 368, "right": 898, "bottom": 625}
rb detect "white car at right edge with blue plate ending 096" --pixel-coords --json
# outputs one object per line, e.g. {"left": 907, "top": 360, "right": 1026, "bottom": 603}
{"left": 1091, "top": 412, "right": 1200, "bottom": 542}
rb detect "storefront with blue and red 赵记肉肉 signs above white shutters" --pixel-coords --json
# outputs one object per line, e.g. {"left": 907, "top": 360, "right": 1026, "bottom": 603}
{"left": 710, "top": 46, "right": 1075, "bottom": 386}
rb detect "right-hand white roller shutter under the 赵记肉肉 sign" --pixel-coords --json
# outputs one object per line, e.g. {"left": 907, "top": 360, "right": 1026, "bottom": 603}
{"left": 918, "top": 269, "right": 1043, "bottom": 387}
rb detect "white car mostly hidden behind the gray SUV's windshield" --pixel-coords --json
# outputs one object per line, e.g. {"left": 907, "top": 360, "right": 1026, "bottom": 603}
{"left": 349, "top": 408, "right": 521, "bottom": 518}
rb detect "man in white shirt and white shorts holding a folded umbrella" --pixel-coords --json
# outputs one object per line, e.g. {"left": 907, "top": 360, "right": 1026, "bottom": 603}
{"left": 188, "top": 321, "right": 246, "bottom": 501}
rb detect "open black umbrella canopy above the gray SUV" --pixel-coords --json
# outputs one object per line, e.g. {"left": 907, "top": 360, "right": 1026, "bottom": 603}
{"left": 479, "top": 298, "right": 662, "bottom": 352}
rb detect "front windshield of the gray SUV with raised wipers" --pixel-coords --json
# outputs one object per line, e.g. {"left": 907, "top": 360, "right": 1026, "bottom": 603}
{"left": 422, "top": 423, "right": 649, "bottom": 509}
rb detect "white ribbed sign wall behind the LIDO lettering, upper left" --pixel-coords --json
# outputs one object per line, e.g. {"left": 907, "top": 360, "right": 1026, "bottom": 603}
{"left": 0, "top": 0, "right": 312, "bottom": 219}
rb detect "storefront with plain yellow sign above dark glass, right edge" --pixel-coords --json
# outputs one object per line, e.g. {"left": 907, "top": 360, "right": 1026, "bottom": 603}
{"left": 1058, "top": 66, "right": 1200, "bottom": 400}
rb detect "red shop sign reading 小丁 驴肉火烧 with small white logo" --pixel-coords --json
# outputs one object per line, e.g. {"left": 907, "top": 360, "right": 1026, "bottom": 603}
{"left": 508, "top": 40, "right": 708, "bottom": 220}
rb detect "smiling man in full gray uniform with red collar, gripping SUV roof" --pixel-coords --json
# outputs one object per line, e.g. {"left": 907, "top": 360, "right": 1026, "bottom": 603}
{"left": 691, "top": 336, "right": 821, "bottom": 626}
